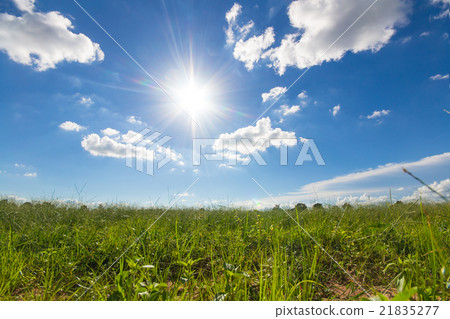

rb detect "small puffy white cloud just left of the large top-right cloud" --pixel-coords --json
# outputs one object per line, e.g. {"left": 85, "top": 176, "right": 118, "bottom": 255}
{"left": 233, "top": 27, "right": 275, "bottom": 70}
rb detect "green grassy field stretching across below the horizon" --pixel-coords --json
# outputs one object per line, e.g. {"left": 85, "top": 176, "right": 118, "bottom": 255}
{"left": 0, "top": 201, "right": 450, "bottom": 300}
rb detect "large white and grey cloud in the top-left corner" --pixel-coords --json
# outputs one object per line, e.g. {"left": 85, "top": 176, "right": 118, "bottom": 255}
{"left": 0, "top": 0, "right": 104, "bottom": 71}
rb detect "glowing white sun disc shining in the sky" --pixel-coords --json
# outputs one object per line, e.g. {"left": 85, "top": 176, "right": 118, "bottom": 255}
{"left": 177, "top": 82, "right": 211, "bottom": 116}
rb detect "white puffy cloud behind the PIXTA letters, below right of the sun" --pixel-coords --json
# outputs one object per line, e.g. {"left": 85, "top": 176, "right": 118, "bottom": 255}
{"left": 213, "top": 117, "right": 297, "bottom": 162}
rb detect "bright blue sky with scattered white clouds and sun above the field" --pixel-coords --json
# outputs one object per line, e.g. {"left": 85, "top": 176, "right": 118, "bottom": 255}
{"left": 0, "top": 0, "right": 450, "bottom": 208}
